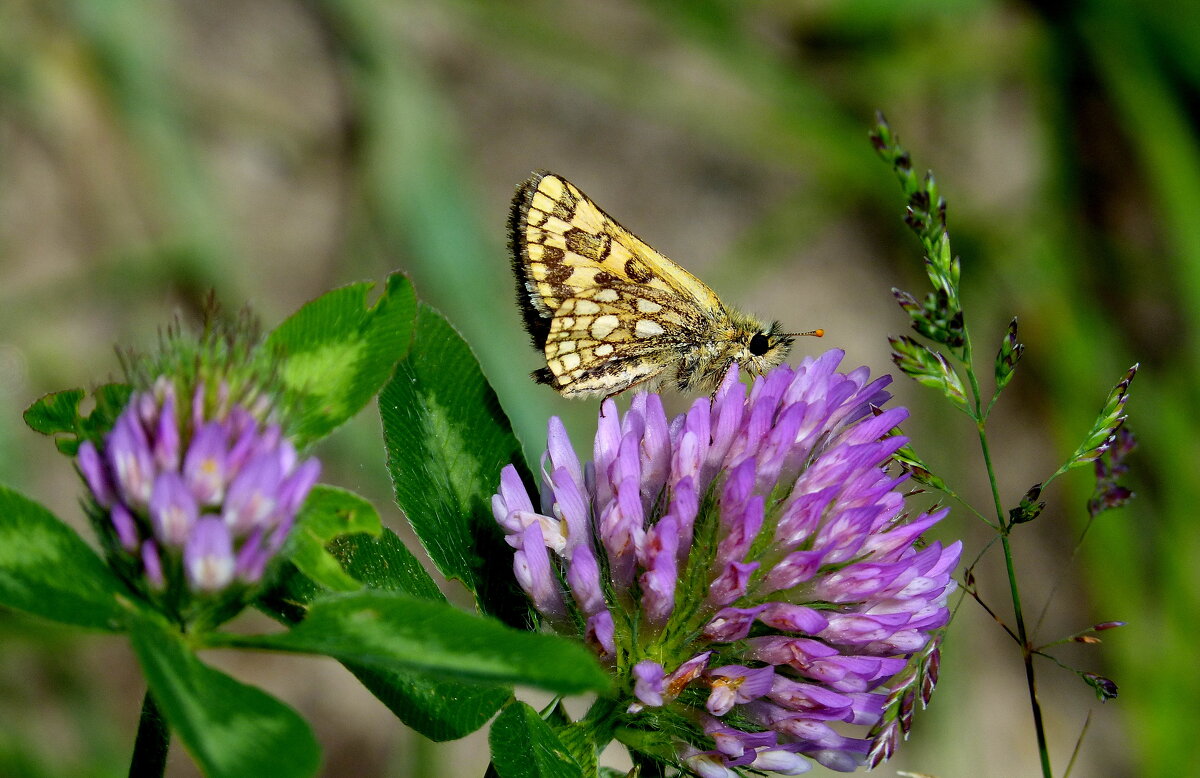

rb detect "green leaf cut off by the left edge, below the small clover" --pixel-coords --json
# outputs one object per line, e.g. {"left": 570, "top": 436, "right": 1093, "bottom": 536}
{"left": 0, "top": 486, "right": 130, "bottom": 632}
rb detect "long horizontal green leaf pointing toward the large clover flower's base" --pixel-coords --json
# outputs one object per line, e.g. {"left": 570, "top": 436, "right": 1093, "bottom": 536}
{"left": 218, "top": 591, "right": 608, "bottom": 694}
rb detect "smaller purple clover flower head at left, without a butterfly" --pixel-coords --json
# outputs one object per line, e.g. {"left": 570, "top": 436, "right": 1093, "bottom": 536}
{"left": 76, "top": 377, "right": 320, "bottom": 602}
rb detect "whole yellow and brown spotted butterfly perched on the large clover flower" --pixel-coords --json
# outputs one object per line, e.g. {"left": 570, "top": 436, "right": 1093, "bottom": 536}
{"left": 509, "top": 170, "right": 824, "bottom": 397}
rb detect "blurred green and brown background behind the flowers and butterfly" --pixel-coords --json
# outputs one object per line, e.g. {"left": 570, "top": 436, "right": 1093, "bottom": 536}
{"left": 0, "top": 0, "right": 1200, "bottom": 778}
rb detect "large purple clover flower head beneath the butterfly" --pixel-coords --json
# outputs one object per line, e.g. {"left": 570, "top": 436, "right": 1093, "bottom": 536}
{"left": 492, "top": 351, "right": 961, "bottom": 778}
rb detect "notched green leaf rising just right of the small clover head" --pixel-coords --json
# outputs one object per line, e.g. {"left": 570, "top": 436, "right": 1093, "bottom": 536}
{"left": 266, "top": 273, "right": 416, "bottom": 445}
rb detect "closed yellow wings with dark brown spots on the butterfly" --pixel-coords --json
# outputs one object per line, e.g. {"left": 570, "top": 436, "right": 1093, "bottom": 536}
{"left": 512, "top": 173, "right": 721, "bottom": 395}
